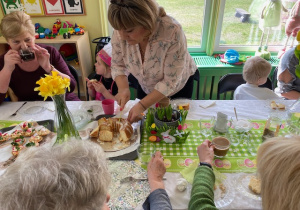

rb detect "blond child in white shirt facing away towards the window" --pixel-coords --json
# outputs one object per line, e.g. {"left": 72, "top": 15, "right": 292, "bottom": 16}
{"left": 234, "top": 56, "right": 280, "bottom": 100}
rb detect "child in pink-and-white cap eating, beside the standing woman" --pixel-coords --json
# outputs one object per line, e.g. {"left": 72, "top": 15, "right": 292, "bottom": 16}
{"left": 86, "top": 43, "right": 118, "bottom": 101}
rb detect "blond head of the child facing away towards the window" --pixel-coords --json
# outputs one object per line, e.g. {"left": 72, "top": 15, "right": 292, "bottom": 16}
{"left": 243, "top": 56, "right": 272, "bottom": 85}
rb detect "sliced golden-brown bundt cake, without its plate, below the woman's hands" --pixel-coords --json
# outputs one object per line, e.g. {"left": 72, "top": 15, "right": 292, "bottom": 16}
{"left": 90, "top": 117, "right": 133, "bottom": 142}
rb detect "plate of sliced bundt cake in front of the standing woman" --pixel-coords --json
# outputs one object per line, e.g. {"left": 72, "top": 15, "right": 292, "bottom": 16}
{"left": 89, "top": 115, "right": 139, "bottom": 152}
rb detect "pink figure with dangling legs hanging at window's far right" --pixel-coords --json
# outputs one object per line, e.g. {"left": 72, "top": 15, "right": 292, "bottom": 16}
{"left": 277, "top": 0, "right": 300, "bottom": 58}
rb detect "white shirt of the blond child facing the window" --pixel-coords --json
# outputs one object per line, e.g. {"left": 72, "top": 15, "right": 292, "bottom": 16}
{"left": 233, "top": 84, "right": 280, "bottom": 100}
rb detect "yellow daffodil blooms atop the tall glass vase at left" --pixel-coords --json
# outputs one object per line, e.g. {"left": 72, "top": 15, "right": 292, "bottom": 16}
{"left": 34, "top": 71, "right": 70, "bottom": 101}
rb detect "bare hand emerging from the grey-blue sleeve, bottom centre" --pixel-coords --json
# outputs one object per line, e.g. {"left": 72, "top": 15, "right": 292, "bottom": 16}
{"left": 147, "top": 151, "right": 166, "bottom": 192}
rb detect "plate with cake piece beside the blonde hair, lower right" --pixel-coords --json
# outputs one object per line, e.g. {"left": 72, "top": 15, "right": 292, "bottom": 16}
{"left": 236, "top": 174, "right": 261, "bottom": 201}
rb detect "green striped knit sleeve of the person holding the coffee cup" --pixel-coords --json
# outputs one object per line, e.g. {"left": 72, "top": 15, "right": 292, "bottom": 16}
{"left": 189, "top": 166, "right": 217, "bottom": 210}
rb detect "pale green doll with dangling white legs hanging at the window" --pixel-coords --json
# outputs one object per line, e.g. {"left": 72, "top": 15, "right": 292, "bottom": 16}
{"left": 255, "top": 0, "right": 287, "bottom": 60}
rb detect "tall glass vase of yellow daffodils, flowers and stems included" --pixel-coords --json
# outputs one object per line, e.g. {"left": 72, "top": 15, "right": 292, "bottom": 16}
{"left": 34, "top": 71, "right": 80, "bottom": 143}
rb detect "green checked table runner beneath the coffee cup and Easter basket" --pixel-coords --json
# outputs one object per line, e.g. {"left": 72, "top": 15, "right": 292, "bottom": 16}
{"left": 141, "top": 120, "right": 288, "bottom": 173}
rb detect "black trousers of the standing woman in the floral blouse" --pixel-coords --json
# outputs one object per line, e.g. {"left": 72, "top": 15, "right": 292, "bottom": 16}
{"left": 137, "top": 74, "right": 195, "bottom": 99}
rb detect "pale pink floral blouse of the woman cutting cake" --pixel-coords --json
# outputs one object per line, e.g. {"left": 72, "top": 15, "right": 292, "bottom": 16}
{"left": 111, "top": 16, "right": 197, "bottom": 96}
